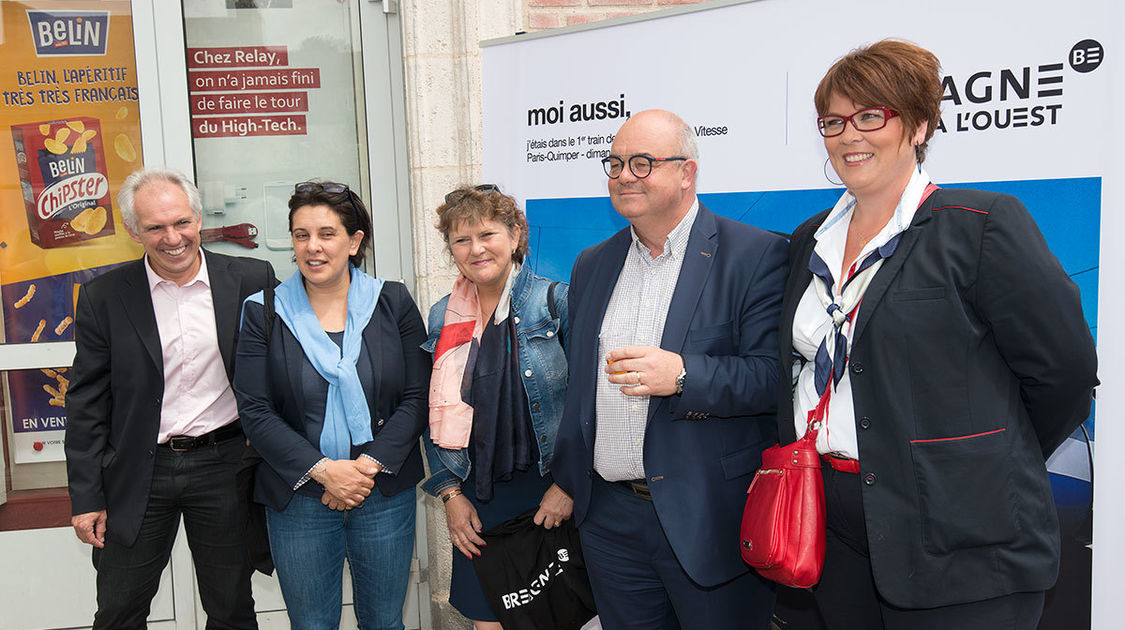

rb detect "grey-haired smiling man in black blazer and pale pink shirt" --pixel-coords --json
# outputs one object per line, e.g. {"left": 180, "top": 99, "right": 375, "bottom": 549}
{"left": 65, "top": 169, "right": 275, "bottom": 629}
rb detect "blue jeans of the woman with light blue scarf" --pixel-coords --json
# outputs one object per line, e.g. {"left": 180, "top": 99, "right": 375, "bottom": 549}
{"left": 266, "top": 488, "right": 414, "bottom": 630}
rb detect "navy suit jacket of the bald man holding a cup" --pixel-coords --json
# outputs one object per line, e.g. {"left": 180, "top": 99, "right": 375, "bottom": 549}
{"left": 551, "top": 205, "right": 786, "bottom": 586}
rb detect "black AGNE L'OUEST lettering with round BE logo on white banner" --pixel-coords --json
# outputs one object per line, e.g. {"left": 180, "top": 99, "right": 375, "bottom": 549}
{"left": 938, "top": 39, "right": 1105, "bottom": 132}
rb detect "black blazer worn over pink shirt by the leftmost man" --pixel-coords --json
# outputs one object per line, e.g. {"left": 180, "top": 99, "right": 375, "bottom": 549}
{"left": 65, "top": 251, "right": 275, "bottom": 546}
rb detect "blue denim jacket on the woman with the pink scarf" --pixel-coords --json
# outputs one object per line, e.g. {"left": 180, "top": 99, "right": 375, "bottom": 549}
{"left": 422, "top": 264, "right": 569, "bottom": 496}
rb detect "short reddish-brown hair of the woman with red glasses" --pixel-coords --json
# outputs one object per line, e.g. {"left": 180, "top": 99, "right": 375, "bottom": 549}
{"left": 813, "top": 39, "right": 942, "bottom": 163}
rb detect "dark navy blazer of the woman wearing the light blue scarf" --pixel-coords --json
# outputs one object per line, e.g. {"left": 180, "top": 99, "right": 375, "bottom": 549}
{"left": 234, "top": 281, "right": 432, "bottom": 511}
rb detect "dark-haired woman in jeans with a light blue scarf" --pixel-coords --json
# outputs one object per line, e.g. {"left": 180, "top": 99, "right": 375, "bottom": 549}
{"left": 234, "top": 182, "right": 430, "bottom": 630}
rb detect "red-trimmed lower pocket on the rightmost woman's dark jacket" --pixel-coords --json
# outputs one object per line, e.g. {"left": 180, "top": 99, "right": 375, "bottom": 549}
{"left": 910, "top": 429, "right": 1017, "bottom": 555}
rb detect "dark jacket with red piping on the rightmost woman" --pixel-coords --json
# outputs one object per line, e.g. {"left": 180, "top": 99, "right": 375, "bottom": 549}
{"left": 777, "top": 189, "right": 1097, "bottom": 609}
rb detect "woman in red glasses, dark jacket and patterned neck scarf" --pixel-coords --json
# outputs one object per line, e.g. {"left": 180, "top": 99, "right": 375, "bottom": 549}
{"left": 779, "top": 41, "right": 1097, "bottom": 630}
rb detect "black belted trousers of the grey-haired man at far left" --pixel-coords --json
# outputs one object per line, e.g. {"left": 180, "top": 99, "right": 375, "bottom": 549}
{"left": 93, "top": 435, "right": 258, "bottom": 630}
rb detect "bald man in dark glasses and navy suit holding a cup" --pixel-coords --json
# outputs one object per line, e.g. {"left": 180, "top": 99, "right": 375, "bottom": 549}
{"left": 551, "top": 110, "right": 786, "bottom": 630}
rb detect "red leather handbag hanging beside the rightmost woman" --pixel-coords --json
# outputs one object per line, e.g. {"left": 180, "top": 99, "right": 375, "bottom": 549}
{"left": 741, "top": 405, "right": 825, "bottom": 588}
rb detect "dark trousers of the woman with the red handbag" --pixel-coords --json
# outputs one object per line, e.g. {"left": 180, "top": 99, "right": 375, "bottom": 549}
{"left": 815, "top": 466, "right": 1044, "bottom": 630}
